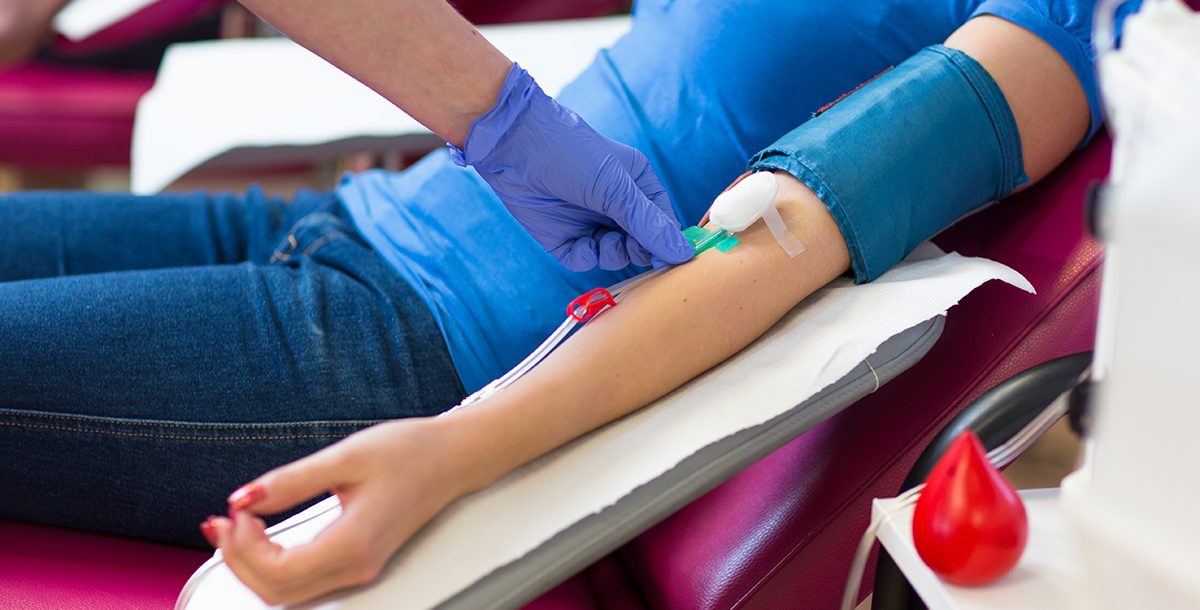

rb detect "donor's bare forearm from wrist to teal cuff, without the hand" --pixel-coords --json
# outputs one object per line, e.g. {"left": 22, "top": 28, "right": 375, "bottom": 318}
{"left": 440, "top": 174, "right": 850, "bottom": 489}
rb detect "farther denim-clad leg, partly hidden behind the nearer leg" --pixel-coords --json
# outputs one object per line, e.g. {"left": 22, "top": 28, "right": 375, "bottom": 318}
{"left": 0, "top": 189, "right": 332, "bottom": 282}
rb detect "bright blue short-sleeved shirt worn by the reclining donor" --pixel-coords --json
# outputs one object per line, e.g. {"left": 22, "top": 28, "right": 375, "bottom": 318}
{"left": 337, "top": 0, "right": 1123, "bottom": 391}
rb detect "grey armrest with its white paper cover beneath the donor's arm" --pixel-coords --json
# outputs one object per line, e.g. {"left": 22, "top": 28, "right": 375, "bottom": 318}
{"left": 178, "top": 244, "right": 1033, "bottom": 610}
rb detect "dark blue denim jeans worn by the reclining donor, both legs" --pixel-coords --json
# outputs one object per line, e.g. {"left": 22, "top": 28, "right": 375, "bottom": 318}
{"left": 0, "top": 191, "right": 464, "bottom": 545}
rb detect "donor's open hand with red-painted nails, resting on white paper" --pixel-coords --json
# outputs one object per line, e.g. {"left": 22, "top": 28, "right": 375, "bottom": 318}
{"left": 200, "top": 419, "right": 469, "bottom": 605}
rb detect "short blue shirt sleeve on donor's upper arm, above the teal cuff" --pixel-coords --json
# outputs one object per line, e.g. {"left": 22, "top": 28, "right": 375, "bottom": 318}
{"left": 968, "top": 0, "right": 1104, "bottom": 148}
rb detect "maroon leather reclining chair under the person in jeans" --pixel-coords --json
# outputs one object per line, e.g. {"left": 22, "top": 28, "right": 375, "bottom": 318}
{"left": 0, "top": 127, "right": 1110, "bottom": 610}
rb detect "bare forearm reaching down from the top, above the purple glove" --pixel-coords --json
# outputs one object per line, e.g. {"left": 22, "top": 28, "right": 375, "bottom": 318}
{"left": 241, "top": 0, "right": 512, "bottom": 146}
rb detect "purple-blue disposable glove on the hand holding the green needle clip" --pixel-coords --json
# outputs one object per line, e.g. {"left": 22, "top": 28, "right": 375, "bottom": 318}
{"left": 450, "top": 64, "right": 692, "bottom": 271}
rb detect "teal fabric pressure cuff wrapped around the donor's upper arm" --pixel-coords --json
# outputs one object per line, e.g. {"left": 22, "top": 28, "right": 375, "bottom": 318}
{"left": 750, "top": 46, "right": 1028, "bottom": 283}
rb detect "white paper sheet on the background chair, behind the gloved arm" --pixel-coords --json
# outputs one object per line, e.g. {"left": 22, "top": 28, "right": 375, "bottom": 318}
{"left": 132, "top": 17, "right": 629, "bottom": 193}
